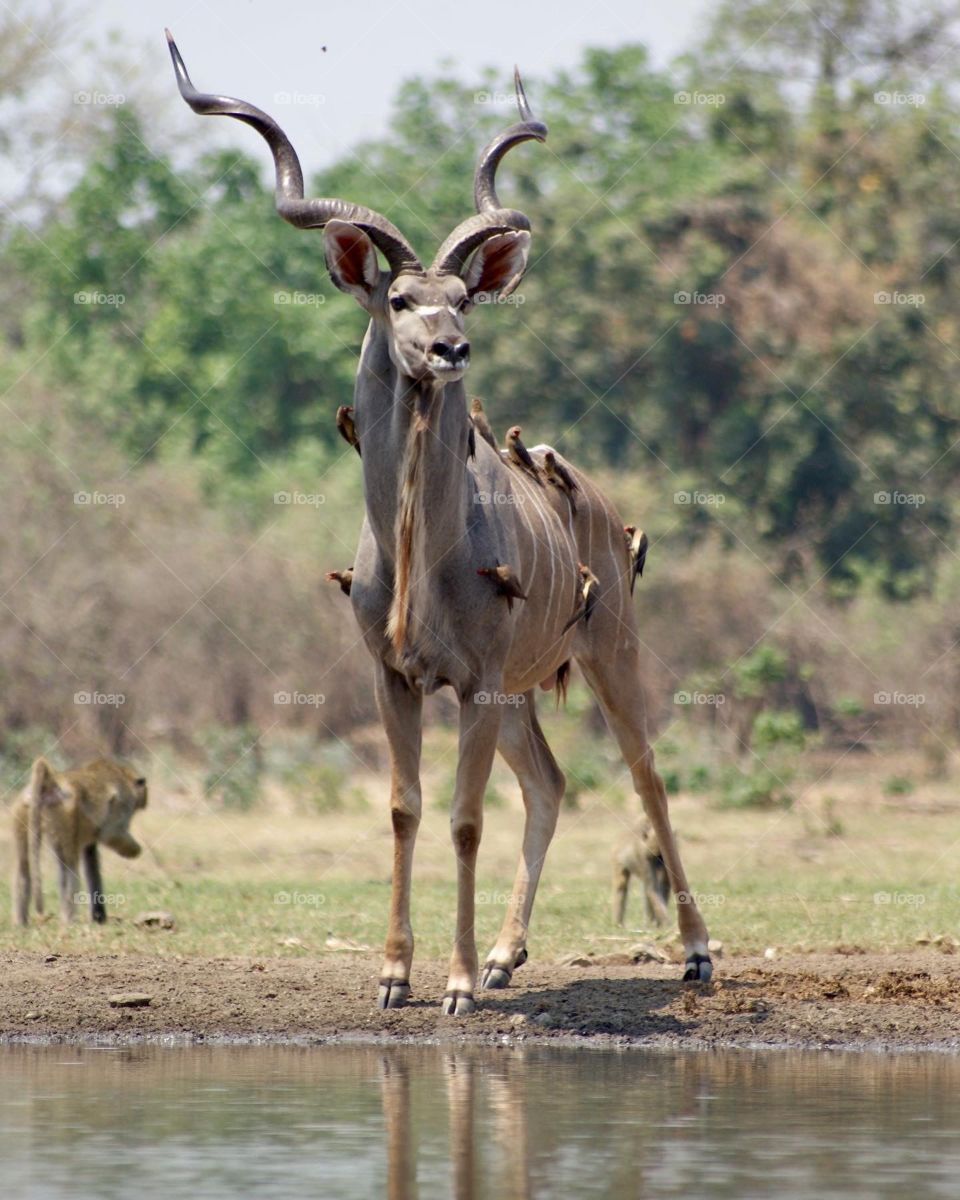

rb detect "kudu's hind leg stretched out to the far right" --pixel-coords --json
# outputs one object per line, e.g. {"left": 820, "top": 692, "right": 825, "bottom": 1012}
{"left": 577, "top": 646, "right": 713, "bottom": 983}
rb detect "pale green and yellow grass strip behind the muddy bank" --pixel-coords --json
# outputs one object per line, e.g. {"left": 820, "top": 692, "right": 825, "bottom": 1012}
{"left": 0, "top": 730, "right": 960, "bottom": 959}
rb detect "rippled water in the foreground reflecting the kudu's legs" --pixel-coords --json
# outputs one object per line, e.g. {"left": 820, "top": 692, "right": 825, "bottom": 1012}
{"left": 0, "top": 1046, "right": 960, "bottom": 1200}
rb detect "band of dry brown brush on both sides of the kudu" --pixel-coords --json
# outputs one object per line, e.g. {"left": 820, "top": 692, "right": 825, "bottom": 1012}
{"left": 0, "top": 385, "right": 945, "bottom": 801}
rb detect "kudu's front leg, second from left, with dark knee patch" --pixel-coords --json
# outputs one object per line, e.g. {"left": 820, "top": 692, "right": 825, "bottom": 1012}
{"left": 443, "top": 688, "right": 502, "bottom": 1016}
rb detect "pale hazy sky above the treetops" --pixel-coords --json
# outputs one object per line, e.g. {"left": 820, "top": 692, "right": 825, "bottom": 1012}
{"left": 82, "top": 0, "right": 710, "bottom": 166}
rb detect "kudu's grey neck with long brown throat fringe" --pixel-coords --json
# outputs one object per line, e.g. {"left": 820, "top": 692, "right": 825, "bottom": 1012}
{"left": 354, "top": 320, "right": 469, "bottom": 574}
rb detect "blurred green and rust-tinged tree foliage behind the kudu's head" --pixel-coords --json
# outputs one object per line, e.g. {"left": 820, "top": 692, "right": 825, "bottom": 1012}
{"left": 0, "top": 9, "right": 960, "bottom": 590}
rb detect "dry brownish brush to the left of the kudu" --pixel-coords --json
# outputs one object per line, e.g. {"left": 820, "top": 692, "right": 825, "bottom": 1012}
{"left": 0, "top": 390, "right": 374, "bottom": 777}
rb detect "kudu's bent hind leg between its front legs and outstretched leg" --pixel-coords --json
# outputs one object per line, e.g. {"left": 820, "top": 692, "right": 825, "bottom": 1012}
{"left": 481, "top": 691, "right": 565, "bottom": 988}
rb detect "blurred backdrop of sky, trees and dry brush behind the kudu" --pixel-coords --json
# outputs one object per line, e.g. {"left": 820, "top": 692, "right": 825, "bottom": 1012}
{"left": 0, "top": 0, "right": 960, "bottom": 830}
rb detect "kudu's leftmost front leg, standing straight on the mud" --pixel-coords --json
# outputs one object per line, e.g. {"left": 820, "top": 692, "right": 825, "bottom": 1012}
{"left": 376, "top": 664, "right": 422, "bottom": 1008}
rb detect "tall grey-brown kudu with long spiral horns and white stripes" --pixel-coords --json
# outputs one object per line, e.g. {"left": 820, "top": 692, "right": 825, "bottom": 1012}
{"left": 167, "top": 34, "right": 712, "bottom": 1015}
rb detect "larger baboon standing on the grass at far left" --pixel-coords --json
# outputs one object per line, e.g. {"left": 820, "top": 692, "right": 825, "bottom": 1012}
{"left": 13, "top": 758, "right": 146, "bottom": 925}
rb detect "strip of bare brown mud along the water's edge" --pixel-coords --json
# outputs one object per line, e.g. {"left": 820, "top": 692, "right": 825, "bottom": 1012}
{"left": 0, "top": 950, "right": 960, "bottom": 1050}
